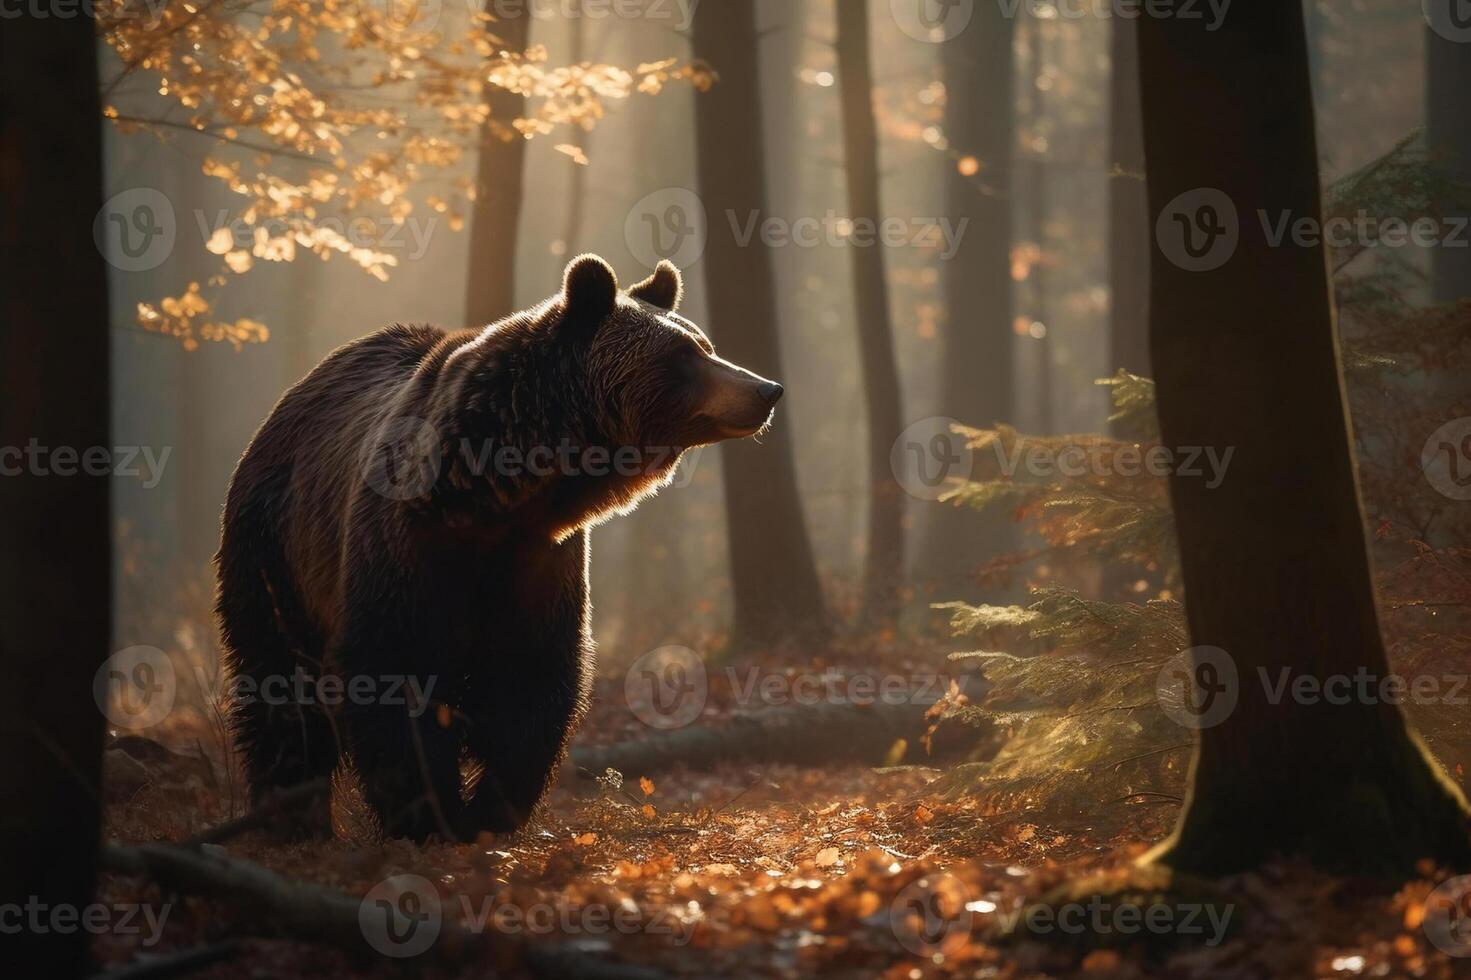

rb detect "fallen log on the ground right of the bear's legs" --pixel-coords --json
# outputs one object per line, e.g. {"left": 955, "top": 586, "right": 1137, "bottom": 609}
{"left": 569, "top": 691, "right": 984, "bottom": 780}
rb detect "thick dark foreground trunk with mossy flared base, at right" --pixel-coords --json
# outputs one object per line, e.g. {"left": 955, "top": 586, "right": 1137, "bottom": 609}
{"left": 1139, "top": 3, "right": 1471, "bottom": 876}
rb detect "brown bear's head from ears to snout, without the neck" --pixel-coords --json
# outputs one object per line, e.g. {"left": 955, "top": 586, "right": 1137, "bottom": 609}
{"left": 556, "top": 255, "right": 781, "bottom": 452}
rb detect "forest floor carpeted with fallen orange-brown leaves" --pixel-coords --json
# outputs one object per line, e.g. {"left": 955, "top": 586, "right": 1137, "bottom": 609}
{"left": 96, "top": 641, "right": 1471, "bottom": 980}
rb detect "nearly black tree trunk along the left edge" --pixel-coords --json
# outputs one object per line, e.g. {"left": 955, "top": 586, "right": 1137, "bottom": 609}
{"left": 0, "top": 15, "right": 112, "bottom": 977}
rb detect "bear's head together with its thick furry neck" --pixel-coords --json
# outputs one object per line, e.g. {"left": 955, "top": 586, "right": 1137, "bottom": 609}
{"left": 427, "top": 248, "right": 781, "bottom": 529}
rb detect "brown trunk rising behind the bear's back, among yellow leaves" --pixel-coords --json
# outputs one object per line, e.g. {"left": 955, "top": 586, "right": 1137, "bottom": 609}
{"left": 465, "top": 3, "right": 531, "bottom": 325}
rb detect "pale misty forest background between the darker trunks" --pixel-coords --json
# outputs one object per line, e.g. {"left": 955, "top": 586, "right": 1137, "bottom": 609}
{"left": 103, "top": 0, "right": 1471, "bottom": 662}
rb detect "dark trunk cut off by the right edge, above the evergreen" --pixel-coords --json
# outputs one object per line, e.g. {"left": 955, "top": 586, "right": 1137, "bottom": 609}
{"left": 1425, "top": 17, "right": 1471, "bottom": 303}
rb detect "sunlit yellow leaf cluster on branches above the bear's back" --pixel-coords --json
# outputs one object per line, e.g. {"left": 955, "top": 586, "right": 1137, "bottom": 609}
{"left": 97, "top": 0, "right": 700, "bottom": 347}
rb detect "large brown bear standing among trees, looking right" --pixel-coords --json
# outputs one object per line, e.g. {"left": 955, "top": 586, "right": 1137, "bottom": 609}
{"left": 215, "top": 255, "right": 781, "bottom": 839}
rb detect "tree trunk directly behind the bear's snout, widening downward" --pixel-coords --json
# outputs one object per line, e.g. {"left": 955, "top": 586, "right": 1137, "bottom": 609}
{"left": 693, "top": 0, "right": 828, "bottom": 647}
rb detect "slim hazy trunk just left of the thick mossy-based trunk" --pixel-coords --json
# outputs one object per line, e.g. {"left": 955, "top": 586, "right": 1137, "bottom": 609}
{"left": 1108, "top": 18, "right": 1150, "bottom": 388}
